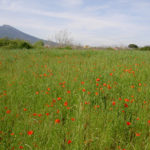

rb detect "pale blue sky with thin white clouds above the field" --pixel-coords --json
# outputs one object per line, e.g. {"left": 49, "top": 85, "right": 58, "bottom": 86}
{"left": 0, "top": 0, "right": 150, "bottom": 46}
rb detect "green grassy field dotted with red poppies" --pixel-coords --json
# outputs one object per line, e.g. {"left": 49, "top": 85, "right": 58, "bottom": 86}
{"left": 0, "top": 50, "right": 150, "bottom": 150}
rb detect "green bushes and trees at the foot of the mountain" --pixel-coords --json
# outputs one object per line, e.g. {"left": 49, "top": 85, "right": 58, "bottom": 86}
{"left": 0, "top": 38, "right": 44, "bottom": 49}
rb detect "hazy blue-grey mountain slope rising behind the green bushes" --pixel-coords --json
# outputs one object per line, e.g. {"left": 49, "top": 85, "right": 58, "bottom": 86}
{"left": 0, "top": 25, "right": 57, "bottom": 46}
